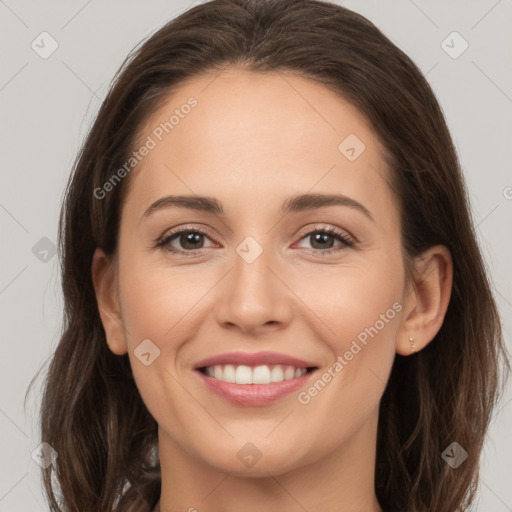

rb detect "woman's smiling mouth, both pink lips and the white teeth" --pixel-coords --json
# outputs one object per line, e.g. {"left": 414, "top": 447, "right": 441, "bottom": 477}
{"left": 194, "top": 352, "right": 318, "bottom": 406}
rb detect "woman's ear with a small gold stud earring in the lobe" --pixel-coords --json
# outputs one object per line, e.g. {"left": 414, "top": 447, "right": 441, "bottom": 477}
{"left": 396, "top": 245, "right": 453, "bottom": 356}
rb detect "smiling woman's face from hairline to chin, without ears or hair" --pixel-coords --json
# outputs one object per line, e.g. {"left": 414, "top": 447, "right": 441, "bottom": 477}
{"left": 109, "top": 68, "right": 407, "bottom": 475}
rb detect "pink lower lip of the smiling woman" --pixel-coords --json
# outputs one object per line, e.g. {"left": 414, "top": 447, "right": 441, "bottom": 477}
{"left": 196, "top": 370, "right": 316, "bottom": 406}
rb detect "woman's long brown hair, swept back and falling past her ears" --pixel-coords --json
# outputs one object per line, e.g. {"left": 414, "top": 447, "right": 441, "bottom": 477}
{"left": 31, "top": 0, "right": 510, "bottom": 512}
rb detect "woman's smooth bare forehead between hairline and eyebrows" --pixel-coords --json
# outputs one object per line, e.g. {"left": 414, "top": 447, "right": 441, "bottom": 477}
{"left": 122, "top": 68, "right": 396, "bottom": 226}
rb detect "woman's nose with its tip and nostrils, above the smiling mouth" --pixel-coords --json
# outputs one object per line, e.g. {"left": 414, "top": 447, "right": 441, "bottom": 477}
{"left": 216, "top": 243, "right": 293, "bottom": 334}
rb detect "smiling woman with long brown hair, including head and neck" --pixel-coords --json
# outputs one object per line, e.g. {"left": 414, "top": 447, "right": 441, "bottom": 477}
{"left": 36, "top": 0, "right": 508, "bottom": 512}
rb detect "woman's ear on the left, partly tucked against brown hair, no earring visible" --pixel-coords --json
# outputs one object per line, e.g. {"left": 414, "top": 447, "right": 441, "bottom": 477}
{"left": 91, "top": 248, "right": 128, "bottom": 355}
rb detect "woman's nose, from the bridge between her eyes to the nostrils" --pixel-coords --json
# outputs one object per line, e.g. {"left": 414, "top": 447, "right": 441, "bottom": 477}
{"left": 217, "top": 236, "right": 290, "bottom": 331}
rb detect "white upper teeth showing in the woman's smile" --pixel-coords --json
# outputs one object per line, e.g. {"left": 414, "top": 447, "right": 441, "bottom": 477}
{"left": 205, "top": 364, "right": 307, "bottom": 384}
